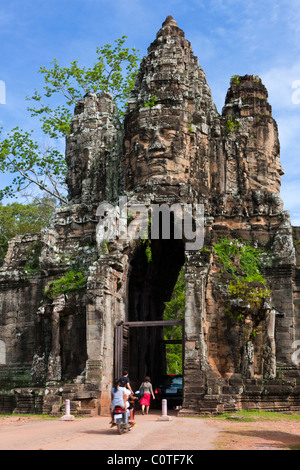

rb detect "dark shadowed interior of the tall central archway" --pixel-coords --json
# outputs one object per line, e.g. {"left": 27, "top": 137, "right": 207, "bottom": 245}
{"left": 127, "top": 239, "right": 185, "bottom": 387}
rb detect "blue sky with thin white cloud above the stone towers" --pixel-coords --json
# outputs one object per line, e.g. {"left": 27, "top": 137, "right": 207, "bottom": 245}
{"left": 0, "top": 0, "right": 300, "bottom": 225}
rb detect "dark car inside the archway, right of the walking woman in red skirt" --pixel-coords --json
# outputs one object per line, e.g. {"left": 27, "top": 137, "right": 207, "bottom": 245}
{"left": 154, "top": 374, "right": 183, "bottom": 409}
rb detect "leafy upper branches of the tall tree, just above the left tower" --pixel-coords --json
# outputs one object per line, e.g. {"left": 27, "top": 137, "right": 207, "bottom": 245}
{"left": 28, "top": 36, "right": 139, "bottom": 138}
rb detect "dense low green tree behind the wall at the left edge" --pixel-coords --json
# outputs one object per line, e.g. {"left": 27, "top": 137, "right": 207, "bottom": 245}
{"left": 0, "top": 198, "right": 53, "bottom": 266}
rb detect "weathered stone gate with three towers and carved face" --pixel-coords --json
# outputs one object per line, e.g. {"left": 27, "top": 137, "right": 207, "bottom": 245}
{"left": 0, "top": 16, "right": 300, "bottom": 414}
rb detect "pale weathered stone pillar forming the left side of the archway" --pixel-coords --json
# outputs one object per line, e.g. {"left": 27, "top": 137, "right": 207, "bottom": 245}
{"left": 86, "top": 254, "right": 126, "bottom": 414}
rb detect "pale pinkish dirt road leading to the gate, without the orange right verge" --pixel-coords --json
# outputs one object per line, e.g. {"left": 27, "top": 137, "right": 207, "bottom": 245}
{"left": 0, "top": 411, "right": 219, "bottom": 451}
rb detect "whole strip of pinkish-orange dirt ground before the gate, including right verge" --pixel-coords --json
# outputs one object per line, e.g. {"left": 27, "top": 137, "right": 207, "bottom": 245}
{"left": 0, "top": 411, "right": 300, "bottom": 452}
